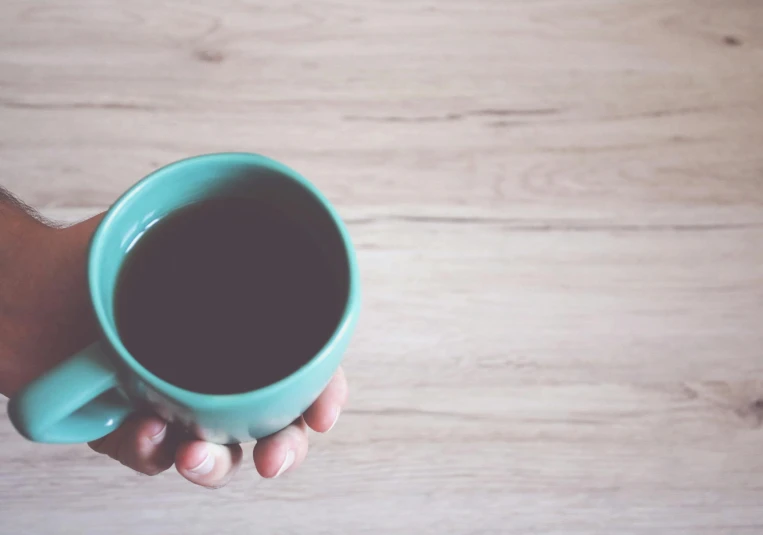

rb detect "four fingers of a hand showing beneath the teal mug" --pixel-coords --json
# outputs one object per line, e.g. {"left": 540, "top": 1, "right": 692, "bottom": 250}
{"left": 89, "top": 368, "right": 347, "bottom": 489}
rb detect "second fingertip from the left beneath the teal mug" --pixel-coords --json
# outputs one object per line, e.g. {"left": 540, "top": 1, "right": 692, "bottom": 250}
{"left": 175, "top": 440, "right": 242, "bottom": 489}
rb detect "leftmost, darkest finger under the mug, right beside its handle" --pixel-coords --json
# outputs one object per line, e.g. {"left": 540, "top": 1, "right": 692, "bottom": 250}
{"left": 88, "top": 416, "right": 174, "bottom": 476}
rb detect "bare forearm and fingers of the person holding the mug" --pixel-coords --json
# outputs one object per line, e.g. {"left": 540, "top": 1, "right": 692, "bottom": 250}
{"left": 0, "top": 188, "right": 347, "bottom": 489}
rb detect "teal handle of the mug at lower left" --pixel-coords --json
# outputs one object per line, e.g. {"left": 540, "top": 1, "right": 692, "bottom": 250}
{"left": 8, "top": 342, "right": 134, "bottom": 444}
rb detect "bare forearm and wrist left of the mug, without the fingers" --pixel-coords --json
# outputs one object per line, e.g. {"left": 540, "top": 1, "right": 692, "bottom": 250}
{"left": 0, "top": 190, "right": 100, "bottom": 396}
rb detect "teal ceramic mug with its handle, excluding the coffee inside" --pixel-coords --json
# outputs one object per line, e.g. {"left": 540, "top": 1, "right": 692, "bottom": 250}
{"left": 8, "top": 153, "right": 360, "bottom": 444}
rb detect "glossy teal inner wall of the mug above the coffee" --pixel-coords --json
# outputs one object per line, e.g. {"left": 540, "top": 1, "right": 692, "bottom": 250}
{"left": 89, "top": 153, "right": 352, "bottom": 396}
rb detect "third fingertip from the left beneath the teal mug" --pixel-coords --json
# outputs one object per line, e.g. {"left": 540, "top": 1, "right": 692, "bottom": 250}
{"left": 253, "top": 418, "right": 307, "bottom": 478}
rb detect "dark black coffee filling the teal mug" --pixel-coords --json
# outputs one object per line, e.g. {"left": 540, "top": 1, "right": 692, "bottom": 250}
{"left": 115, "top": 198, "right": 347, "bottom": 394}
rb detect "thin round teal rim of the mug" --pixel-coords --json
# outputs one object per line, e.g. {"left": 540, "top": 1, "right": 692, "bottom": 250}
{"left": 87, "top": 152, "right": 360, "bottom": 405}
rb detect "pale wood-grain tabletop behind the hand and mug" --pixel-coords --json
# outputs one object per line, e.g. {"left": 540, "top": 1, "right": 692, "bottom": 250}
{"left": 0, "top": 0, "right": 763, "bottom": 535}
